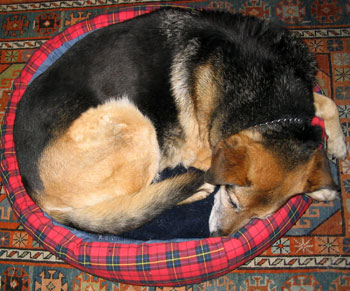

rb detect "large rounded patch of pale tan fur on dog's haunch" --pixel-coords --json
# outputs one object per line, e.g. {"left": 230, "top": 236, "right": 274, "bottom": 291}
{"left": 39, "top": 99, "right": 160, "bottom": 224}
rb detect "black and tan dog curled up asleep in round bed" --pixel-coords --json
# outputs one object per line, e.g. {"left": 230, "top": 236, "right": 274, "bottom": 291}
{"left": 14, "top": 8, "right": 346, "bottom": 235}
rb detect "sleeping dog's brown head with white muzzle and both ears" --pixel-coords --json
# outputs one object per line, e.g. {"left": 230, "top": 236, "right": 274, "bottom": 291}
{"left": 206, "top": 131, "right": 334, "bottom": 236}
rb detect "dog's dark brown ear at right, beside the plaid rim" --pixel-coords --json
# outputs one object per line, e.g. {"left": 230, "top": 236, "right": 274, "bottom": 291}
{"left": 305, "top": 150, "right": 337, "bottom": 193}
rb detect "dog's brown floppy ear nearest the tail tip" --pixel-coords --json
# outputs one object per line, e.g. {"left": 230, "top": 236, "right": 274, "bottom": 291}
{"left": 205, "top": 135, "right": 249, "bottom": 186}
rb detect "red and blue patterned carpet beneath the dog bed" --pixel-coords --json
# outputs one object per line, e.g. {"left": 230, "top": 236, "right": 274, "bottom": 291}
{"left": 0, "top": 0, "right": 350, "bottom": 291}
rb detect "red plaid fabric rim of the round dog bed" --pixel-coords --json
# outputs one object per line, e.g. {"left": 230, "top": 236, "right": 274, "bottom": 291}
{"left": 0, "top": 7, "right": 311, "bottom": 286}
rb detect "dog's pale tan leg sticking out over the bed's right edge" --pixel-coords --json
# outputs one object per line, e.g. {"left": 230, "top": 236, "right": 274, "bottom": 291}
{"left": 314, "top": 93, "right": 346, "bottom": 159}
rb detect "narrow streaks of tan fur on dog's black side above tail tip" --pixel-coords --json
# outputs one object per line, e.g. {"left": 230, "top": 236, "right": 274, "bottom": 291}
{"left": 168, "top": 64, "right": 217, "bottom": 171}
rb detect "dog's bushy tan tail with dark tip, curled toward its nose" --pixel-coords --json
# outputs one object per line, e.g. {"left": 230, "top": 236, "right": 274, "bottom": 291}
{"left": 60, "top": 170, "right": 204, "bottom": 234}
